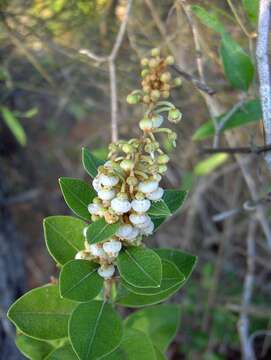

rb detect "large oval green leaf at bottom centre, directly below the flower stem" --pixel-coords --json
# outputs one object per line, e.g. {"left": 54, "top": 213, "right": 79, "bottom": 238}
{"left": 69, "top": 301, "right": 122, "bottom": 360}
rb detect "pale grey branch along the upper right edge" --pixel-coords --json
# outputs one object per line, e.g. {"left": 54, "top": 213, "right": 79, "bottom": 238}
{"left": 256, "top": 0, "right": 271, "bottom": 171}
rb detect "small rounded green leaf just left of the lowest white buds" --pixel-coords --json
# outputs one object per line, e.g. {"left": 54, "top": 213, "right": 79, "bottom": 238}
{"left": 59, "top": 260, "right": 103, "bottom": 302}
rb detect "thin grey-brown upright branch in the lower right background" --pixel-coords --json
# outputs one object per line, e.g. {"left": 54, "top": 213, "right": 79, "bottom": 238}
{"left": 238, "top": 219, "right": 257, "bottom": 360}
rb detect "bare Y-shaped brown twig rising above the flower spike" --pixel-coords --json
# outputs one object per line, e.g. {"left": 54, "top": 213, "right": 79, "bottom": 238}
{"left": 79, "top": 0, "right": 133, "bottom": 142}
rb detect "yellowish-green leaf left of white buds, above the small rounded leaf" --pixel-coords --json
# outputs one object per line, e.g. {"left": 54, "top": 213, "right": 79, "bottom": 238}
{"left": 43, "top": 216, "right": 87, "bottom": 265}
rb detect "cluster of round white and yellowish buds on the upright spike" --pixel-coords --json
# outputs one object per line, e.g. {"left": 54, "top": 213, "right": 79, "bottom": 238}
{"left": 76, "top": 50, "right": 184, "bottom": 279}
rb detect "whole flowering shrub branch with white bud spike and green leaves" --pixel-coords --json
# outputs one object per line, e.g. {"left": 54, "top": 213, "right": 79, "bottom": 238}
{"left": 8, "top": 49, "right": 196, "bottom": 360}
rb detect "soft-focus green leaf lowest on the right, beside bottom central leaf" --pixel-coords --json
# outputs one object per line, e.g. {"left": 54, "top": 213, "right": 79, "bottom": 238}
{"left": 125, "top": 304, "right": 181, "bottom": 352}
